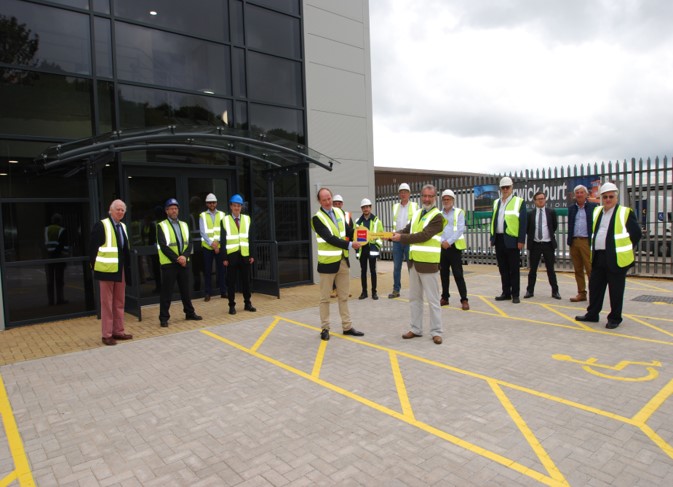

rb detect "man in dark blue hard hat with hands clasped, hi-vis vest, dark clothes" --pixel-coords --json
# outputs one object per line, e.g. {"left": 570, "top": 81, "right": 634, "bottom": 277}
{"left": 157, "top": 198, "right": 202, "bottom": 327}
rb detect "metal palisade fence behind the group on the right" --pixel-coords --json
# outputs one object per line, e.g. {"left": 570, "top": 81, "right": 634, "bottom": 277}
{"left": 376, "top": 156, "right": 673, "bottom": 277}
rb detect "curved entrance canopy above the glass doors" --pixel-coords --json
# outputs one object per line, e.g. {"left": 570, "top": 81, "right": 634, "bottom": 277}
{"left": 35, "top": 125, "right": 338, "bottom": 172}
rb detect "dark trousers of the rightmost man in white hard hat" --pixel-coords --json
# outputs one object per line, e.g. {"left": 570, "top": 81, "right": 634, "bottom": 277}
{"left": 587, "top": 250, "right": 626, "bottom": 323}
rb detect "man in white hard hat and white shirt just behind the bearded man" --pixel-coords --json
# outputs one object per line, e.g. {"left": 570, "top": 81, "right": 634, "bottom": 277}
{"left": 439, "top": 189, "right": 470, "bottom": 311}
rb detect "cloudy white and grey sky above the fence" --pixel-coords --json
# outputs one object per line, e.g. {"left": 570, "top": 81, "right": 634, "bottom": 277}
{"left": 369, "top": 0, "right": 673, "bottom": 172}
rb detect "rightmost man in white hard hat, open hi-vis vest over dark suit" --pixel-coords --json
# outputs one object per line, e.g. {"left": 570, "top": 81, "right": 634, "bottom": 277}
{"left": 575, "top": 183, "right": 643, "bottom": 329}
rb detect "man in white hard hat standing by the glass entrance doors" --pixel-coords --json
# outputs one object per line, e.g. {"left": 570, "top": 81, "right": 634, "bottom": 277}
{"left": 199, "top": 193, "right": 227, "bottom": 301}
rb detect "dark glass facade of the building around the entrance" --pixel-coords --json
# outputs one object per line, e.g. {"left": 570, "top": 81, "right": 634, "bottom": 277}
{"left": 0, "top": 0, "right": 312, "bottom": 327}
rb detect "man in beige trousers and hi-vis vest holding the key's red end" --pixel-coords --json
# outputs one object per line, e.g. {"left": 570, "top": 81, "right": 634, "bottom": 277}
{"left": 311, "top": 188, "right": 364, "bottom": 340}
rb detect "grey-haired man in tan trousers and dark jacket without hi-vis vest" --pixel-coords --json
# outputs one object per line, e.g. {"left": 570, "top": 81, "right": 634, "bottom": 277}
{"left": 568, "top": 184, "right": 597, "bottom": 303}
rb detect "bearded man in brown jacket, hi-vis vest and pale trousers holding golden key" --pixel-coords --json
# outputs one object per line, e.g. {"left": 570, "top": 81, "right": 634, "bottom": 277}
{"left": 392, "top": 184, "right": 445, "bottom": 345}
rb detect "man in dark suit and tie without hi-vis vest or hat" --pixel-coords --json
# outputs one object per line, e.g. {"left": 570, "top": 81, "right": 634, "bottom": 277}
{"left": 524, "top": 191, "right": 561, "bottom": 299}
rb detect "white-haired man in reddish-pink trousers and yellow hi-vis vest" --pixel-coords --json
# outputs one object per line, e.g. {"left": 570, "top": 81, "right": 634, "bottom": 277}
{"left": 89, "top": 200, "right": 133, "bottom": 345}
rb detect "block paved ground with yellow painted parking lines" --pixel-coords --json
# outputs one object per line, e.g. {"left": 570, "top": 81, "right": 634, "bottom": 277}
{"left": 0, "top": 262, "right": 673, "bottom": 487}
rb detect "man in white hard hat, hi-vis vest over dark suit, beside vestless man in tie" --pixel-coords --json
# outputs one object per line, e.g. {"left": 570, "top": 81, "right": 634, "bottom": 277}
{"left": 491, "top": 176, "right": 526, "bottom": 304}
